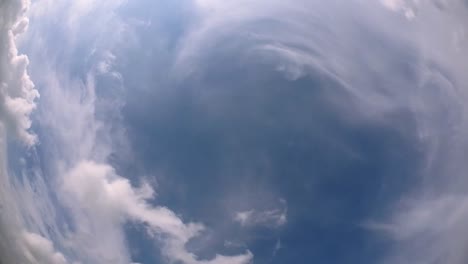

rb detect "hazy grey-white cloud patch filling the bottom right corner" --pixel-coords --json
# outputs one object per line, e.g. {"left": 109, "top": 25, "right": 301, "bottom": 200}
{"left": 366, "top": 195, "right": 468, "bottom": 264}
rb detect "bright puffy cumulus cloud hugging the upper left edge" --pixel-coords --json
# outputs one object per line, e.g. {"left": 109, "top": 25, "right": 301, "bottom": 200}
{"left": 0, "top": 0, "right": 39, "bottom": 145}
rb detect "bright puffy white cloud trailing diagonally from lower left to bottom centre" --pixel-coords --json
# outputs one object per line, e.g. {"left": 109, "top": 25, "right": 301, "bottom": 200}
{"left": 63, "top": 161, "right": 252, "bottom": 264}
